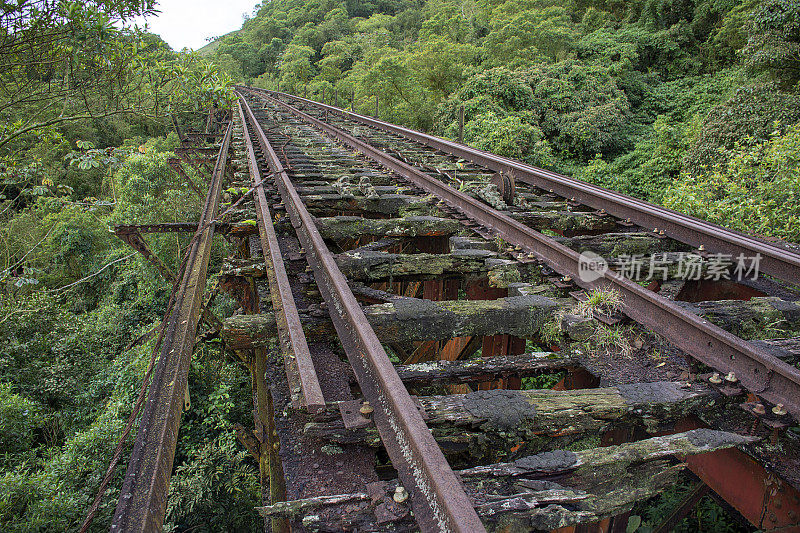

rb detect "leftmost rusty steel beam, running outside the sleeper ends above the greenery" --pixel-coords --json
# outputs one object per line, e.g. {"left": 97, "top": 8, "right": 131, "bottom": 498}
{"left": 111, "top": 124, "right": 233, "bottom": 532}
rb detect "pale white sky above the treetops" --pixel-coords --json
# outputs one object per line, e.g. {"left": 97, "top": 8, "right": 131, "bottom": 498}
{"left": 130, "top": 0, "right": 258, "bottom": 51}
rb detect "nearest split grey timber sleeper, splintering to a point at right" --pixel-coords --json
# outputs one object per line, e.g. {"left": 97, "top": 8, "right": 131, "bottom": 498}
{"left": 259, "top": 429, "right": 757, "bottom": 531}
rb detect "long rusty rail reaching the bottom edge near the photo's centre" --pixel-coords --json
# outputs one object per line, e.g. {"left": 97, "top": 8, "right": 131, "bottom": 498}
{"left": 240, "top": 93, "right": 485, "bottom": 533}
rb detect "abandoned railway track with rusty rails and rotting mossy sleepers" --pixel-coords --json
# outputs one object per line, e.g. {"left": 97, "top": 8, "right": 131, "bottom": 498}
{"left": 112, "top": 87, "right": 800, "bottom": 531}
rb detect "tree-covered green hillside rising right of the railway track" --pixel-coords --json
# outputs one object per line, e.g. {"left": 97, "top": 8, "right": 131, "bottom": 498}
{"left": 211, "top": 0, "right": 800, "bottom": 241}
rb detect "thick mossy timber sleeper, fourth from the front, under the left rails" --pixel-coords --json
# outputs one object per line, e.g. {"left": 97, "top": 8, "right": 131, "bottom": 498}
{"left": 222, "top": 296, "right": 562, "bottom": 348}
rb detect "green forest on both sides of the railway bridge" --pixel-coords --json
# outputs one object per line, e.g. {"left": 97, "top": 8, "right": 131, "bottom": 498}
{"left": 0, "top": 0, "right": 800, "bottom": 532}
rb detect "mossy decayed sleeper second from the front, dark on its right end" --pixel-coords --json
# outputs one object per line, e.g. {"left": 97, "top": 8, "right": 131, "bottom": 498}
{"left": 305, "top": 382, "right": 721, "bottom": 462}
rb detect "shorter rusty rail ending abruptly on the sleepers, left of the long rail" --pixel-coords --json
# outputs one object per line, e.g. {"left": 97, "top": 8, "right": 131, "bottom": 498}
{"left": 239, "top": 105, "right": 325, "bottom": 412}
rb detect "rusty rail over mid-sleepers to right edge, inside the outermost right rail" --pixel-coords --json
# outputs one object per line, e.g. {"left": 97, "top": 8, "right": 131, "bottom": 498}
{"left": 252, "top": 89, "right": 800, "bottom": 419}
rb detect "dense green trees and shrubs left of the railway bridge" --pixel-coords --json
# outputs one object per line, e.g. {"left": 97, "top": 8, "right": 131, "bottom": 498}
{"left": 0, "top": 0, "right": 253, "bottom": 532}
